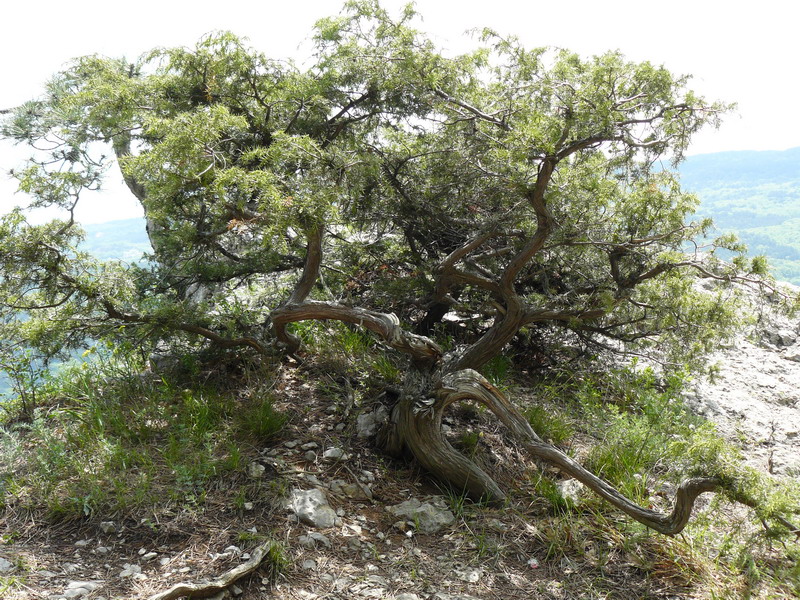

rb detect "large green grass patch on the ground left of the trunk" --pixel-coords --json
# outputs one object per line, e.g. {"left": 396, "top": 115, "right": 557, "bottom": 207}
{"left": 0, "top": 346, "right": 286, "bottom": 520}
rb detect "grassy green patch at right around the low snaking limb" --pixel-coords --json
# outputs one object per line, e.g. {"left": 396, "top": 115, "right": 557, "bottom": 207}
{"left": 527, "top": 364, "right": 800, "bottom": 598}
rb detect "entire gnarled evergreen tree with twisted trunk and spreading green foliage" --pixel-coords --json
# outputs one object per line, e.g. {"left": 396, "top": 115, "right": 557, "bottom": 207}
{"left": 0, "top": 0, "right": 792, "bottom": 533}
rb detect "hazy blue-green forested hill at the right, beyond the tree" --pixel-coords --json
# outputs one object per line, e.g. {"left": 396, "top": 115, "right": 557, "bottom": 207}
{"left": 680, "top": 148, "right": 800, "bottom": 285}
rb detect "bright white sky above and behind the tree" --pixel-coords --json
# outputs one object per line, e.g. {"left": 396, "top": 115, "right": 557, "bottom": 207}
{"left": 0, "top": 0, "right": 800, "bottom": 223}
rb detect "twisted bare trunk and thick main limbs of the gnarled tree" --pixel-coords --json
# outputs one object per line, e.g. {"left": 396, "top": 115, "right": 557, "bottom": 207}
{"left": 271, "top": 223, "right": 791, "bottom": 535}
